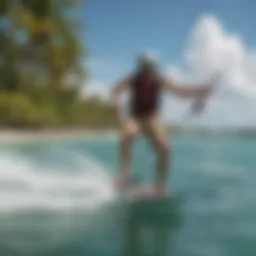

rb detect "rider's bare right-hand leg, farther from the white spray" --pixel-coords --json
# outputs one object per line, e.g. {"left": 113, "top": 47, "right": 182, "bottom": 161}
{"left": 145, "top": 117, "right": 170, "bottom": 193}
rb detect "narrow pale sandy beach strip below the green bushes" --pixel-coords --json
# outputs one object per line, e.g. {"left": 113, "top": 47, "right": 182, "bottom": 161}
{"left": 0, "top": 129, "right": 118, "bottom": 144}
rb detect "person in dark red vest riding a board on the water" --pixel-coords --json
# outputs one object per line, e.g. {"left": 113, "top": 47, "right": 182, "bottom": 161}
{"left": 111, "top": 53, "right": 212, "bottom": 195}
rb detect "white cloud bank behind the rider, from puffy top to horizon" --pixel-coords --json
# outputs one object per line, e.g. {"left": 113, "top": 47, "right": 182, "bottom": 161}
{"left": 88, "top": 15, "right": 256, "bottom": 127}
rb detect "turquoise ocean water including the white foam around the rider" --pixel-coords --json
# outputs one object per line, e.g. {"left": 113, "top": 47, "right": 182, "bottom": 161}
{"left": 0, "top": 137, "right": 256, "bottom": 256}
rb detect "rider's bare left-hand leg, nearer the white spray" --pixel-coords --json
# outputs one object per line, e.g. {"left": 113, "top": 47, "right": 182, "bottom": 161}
{"left": 118, "top": 119, "right": 140, "bottom": 187}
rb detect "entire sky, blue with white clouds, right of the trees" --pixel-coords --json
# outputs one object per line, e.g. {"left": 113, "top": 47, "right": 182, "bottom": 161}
{"left": 81, "top": 0, "right": 256, "bottom": 127}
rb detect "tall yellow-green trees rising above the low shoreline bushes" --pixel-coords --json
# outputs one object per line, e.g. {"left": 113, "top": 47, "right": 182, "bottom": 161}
{"left": 0, "top": 0, "right": 84, "bottom": 93}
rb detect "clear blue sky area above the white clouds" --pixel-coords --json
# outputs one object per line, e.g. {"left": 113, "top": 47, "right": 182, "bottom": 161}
{"left": 83, "top": 0, "right": 256, "bottom": 82}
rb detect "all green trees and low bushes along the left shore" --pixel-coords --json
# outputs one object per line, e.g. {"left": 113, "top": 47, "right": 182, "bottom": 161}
{"left": 0, "top": 0, "right": 117, "bottom": 128}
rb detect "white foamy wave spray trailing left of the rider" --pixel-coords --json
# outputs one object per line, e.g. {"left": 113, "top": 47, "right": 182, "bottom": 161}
{"left": 0, "top": 149, "right": 115, "bottom": 212}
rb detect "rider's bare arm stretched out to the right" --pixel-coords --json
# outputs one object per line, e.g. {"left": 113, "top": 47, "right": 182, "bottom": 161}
{"left": 162, "top": 77, "right": 212, "bottom": 98}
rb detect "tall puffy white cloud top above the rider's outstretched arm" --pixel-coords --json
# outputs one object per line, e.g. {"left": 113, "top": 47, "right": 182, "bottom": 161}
{"left": 184, "top": 15, "right": 256, "bottom": 90}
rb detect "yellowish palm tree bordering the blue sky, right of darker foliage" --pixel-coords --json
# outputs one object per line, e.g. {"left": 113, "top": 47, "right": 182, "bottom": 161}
{"left": 19, "top": 0, "right": 85, "bottom": 88}
